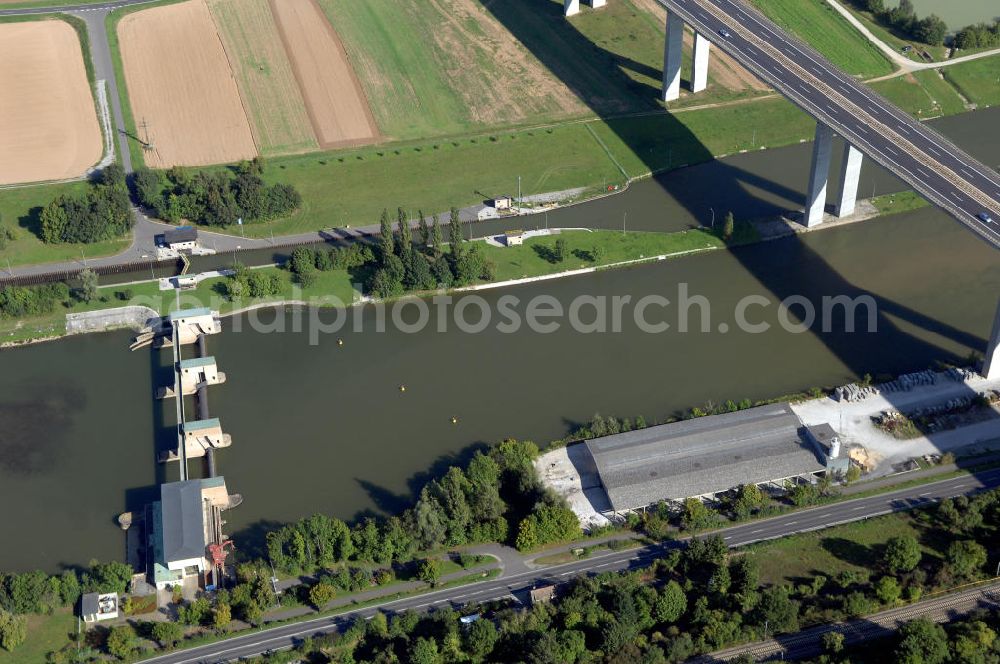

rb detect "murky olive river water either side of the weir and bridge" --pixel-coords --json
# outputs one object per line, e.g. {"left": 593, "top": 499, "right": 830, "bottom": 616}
{"left": 0, "top": 109, "right": 1000, "bottom": 570}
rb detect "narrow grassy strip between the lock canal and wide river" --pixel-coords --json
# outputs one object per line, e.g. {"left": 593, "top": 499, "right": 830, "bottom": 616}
{"left": 0, "top": 192, "right": 926, "bottom": 349}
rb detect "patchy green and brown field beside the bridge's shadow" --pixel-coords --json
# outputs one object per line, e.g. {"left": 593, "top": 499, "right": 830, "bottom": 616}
{"left": 319, "top": 0, "right": 587, "bottom": 139}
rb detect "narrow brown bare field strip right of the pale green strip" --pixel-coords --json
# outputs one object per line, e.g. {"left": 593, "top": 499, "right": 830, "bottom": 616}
{"left": 271, "top": 0, "right": 378, "bottom": 147}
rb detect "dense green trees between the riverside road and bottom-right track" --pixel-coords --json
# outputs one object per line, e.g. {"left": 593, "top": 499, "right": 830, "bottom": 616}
{"left": 273, "top": 491, "right": 1000, "bottom": 664}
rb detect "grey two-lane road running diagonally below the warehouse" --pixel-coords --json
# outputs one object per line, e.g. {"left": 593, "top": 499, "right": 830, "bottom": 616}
{"left": 137, "top": 469, "right": 1000, "bottom": 664}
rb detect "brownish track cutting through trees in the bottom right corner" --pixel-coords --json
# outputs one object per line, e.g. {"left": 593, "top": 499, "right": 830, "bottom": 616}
{"left": 691, "top": 583, "right": 1000, "bottom": 664}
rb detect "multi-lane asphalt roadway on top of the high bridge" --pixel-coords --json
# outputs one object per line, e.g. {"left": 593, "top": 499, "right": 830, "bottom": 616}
{"left": 659, "top": 0, "right": 1000, "bottom": 248}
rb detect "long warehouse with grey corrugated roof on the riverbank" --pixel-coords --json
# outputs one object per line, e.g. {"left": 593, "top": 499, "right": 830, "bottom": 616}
{"left": 585, "top": 403, "right": 827, "bottom": 512}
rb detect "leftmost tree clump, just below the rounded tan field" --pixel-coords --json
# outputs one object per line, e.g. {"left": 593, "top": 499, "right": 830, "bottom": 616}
{"left": 40, "top": 164, "right": 132, "bottom": 244}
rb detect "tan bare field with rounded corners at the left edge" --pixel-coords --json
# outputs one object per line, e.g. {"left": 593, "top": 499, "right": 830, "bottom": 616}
{"left": 0, "top": 20, "right": 104, "bottom": 184}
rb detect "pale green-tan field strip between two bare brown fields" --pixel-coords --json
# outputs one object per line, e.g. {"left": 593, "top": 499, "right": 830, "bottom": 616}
{"left": 208, "top": 0, "right": 318, "bottom": 155}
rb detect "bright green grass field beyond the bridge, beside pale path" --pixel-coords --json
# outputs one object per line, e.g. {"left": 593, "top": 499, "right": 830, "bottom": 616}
{"left": 752, "top": 0, "right": 894, "bottom": 78}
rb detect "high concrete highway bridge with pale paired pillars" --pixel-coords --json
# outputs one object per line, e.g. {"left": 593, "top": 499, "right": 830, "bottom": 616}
{"left": 565, "top": 0, "right": 1000, "bottom": 378}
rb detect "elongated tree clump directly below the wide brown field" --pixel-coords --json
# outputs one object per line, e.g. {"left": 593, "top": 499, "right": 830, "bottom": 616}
{"left": 134, "top": 157, "right": 302, "bottom": 226}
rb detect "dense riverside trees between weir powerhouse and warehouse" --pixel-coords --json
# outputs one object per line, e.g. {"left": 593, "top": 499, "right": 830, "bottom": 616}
{"left": 267, "top": 440, "right": 580, "bottom": 573}
